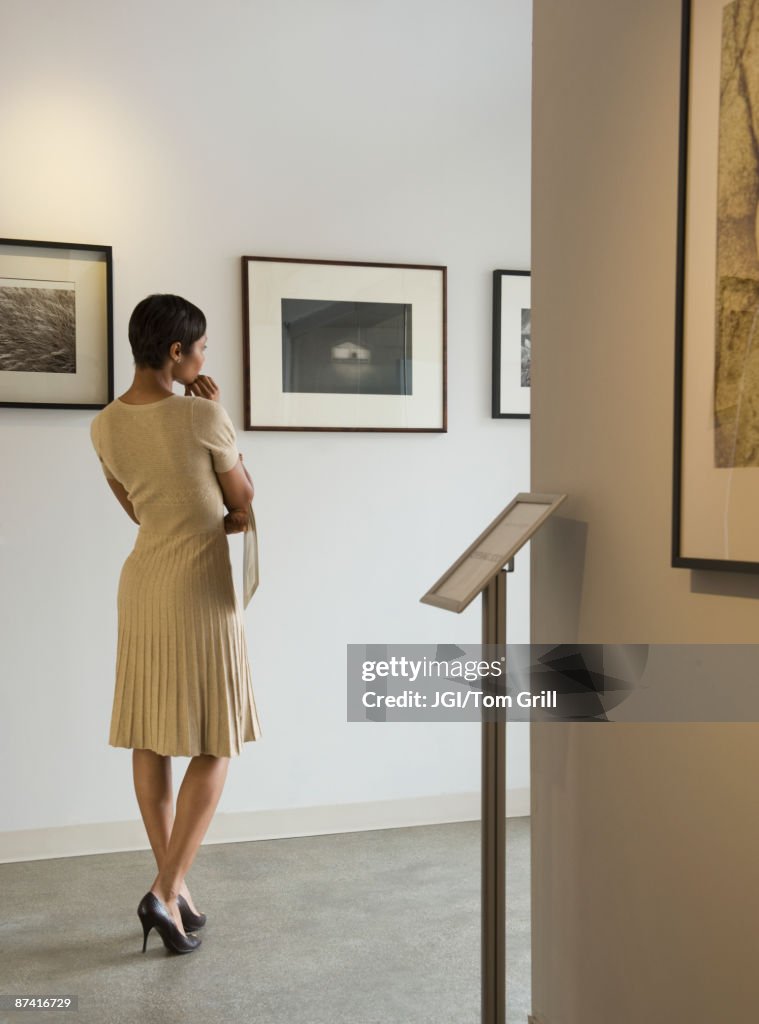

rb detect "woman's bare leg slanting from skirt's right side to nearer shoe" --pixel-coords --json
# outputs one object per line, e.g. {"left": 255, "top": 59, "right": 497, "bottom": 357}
{"left": 151, "top": 754, "right": 229, "bottom": 931}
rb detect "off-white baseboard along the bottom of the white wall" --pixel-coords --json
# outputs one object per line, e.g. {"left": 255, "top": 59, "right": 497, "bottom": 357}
{"left": 0, "top": 787, "right": 530, "bottom": 864}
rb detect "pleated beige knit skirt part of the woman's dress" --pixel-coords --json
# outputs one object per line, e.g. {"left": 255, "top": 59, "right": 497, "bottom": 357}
{"left": 109, "top": 524, "right": 261, "bottom": 757}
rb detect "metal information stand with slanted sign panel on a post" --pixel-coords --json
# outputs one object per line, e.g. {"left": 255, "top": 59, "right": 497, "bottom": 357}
{"left": 421, "top": 494, "right": 566, "bottom": 1024}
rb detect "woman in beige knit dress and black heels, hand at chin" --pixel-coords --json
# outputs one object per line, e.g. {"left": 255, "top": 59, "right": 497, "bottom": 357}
{"left": 90, "top": 295, "right": 261, "bottom": 953}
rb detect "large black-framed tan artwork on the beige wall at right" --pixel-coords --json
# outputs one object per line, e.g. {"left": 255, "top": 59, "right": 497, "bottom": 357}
{"left": 672, "top": 0, "right": 759, "bottom": 572}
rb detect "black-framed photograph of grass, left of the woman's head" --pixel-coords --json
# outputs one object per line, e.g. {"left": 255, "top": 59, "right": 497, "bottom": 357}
{"left": 0, "top": 239, "right": 114, "bottom": 409}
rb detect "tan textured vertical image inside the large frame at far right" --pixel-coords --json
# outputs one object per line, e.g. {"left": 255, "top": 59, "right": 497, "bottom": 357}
{"left": 714, "top": 0, "right": 759, "bottom": 467}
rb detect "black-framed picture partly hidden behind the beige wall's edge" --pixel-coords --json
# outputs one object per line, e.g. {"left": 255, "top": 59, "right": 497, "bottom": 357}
{"left": 493, "top": 270, "right": 532, "bottom": 420}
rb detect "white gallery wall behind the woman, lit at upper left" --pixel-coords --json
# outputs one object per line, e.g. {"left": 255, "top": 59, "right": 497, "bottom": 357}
{"left": 0, "top": 0, "right": 532, "bottom": 854}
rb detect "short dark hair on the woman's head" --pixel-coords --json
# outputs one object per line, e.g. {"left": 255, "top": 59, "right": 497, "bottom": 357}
{"left": 129, "top": 295, "right": 206, "bottom": 370}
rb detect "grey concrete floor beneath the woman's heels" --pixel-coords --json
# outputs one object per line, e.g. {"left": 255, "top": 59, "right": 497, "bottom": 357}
{"left": 0, "top": 818, "right": 530, "bottom": 1024}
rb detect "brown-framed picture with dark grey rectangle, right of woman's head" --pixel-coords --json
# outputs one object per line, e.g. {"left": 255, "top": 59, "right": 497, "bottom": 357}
{"left": 243, "top": 256, "right": 447, "bottom": 431}
